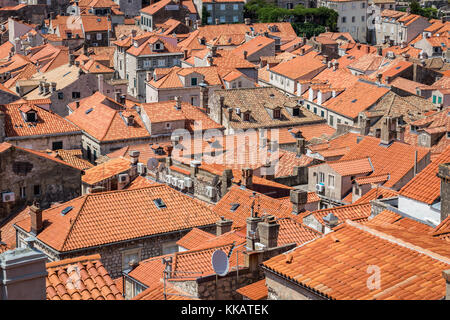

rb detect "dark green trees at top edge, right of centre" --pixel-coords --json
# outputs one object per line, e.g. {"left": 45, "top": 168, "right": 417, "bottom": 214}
{"left": 244, "top": 0, "right": 338, "bottom": 37}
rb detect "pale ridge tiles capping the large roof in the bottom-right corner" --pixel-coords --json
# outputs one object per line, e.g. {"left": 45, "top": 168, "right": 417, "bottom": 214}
{"left": 345, "top": 219, "right": 450, "bottom": 265}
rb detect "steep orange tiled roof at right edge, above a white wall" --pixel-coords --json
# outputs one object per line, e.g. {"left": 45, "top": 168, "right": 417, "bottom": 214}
{"left": 400, "top": 146, "right": 450, "bottom": 205}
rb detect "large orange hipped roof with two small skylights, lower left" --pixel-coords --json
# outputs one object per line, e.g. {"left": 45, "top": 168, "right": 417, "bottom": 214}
{"left": 16, "top": 185, "right": 218, "bottom": 252}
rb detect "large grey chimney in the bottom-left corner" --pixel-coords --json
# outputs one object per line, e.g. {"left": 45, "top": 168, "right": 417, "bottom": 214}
{"left": 0, "top": 248, "right": 47, "bottom": 300}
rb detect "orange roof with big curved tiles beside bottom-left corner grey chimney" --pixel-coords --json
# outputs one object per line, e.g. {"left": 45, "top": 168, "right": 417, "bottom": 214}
{"left": 46, "top": 254, "right": 124, "bottom": 300}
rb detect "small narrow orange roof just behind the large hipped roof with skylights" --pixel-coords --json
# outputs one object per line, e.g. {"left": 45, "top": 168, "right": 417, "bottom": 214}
{"left": 81, "top": 158, "right": 131, "bottom": 185}
